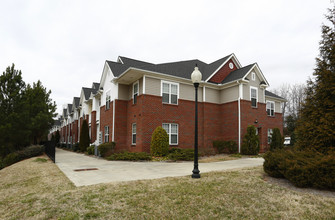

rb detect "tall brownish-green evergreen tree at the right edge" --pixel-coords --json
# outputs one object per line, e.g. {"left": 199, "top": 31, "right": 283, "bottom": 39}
{"left": 297, "top": 8, "right": 335, "bottom": 153}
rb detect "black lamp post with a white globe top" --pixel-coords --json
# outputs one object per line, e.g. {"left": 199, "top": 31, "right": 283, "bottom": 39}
{"left": 191, "top": 64, "right": 202, "bottom": 178}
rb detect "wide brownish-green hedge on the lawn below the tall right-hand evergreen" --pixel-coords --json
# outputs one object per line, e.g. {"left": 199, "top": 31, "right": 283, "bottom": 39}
{"left": 263, "top": 149, "right": 335, "bottom": 190}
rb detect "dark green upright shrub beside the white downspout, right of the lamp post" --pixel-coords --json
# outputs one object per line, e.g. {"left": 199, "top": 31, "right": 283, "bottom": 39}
{"left": 241, "top": 125, "right": 259, "bottom": 155}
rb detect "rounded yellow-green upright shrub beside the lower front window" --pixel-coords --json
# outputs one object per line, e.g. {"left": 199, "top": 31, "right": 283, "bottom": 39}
{"left": 150, "top": 126, "right": 169, "bottom": 157}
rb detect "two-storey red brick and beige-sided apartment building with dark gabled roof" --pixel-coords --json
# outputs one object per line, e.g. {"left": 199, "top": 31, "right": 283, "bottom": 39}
{"left": 52, "top": 54, "right": 285, "bottom": 152}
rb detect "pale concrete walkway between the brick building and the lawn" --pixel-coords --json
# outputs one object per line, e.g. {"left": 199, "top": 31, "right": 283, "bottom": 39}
{"left": 56, "top": 148, "right": 264, "bottom": 186}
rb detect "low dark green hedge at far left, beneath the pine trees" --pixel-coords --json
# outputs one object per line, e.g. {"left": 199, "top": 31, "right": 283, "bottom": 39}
{"left": 0, "top": 145, "right": 44, "bottom": 169}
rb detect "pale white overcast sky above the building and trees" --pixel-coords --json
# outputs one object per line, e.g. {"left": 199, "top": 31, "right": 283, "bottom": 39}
{"left": 0, "top": 0, "right": 334, "bottom": 115}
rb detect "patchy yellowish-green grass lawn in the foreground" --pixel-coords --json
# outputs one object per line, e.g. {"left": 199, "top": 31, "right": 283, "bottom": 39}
{"left": 0, "top": 157, "right": 335, "bottom": 219}
